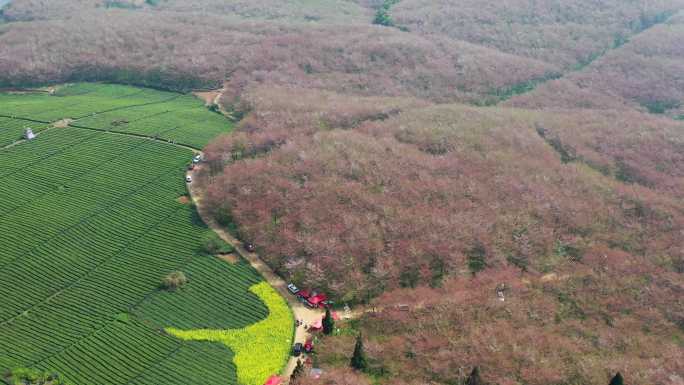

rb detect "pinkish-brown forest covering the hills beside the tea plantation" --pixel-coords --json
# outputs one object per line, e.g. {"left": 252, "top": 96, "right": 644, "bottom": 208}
{"left": 0, "top": 0, "right": 684, "bottom": 385}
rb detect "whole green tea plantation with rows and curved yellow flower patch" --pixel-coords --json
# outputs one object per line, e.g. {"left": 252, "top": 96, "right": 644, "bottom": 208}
{"left": 0, "top": 84, "right": 293, "bottom": 385}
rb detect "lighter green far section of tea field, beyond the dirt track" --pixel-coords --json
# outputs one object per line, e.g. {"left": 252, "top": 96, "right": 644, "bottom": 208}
{"left": 0, "top": 83, "right": 232, "bottom": 148}
